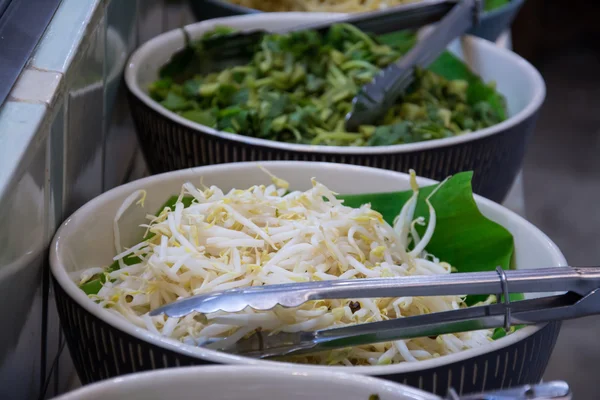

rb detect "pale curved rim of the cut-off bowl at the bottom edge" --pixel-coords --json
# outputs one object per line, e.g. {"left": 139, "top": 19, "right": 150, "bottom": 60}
{"left": 55, "top": 365, "right": 440, "bottom": 400}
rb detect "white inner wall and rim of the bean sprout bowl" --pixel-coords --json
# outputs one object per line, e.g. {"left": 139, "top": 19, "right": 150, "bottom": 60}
{"left": 51, "top": 161, "right": 566, "bottom": 373}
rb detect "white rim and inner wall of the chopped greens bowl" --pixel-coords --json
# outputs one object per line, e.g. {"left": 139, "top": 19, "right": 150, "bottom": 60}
{"left": 125, "top": 12, "right": 546, "bottom": 154}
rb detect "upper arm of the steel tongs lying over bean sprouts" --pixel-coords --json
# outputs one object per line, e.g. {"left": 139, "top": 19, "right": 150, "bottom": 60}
{"left": 150, "top": 267, "right": 600, "bottom": 317}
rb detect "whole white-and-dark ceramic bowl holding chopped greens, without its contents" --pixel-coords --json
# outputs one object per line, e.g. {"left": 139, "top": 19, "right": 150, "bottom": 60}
{"left": 125, "top": 13, "right": 545, "bottom": 201}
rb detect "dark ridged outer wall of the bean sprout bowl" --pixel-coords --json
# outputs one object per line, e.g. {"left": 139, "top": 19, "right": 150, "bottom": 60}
{"left": 54, "top": 280, "right": 560, "bottom": 396}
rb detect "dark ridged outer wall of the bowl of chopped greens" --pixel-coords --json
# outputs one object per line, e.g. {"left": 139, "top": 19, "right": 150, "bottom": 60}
{"left": 129, "top": 92, "right": 537, "bottom": 202}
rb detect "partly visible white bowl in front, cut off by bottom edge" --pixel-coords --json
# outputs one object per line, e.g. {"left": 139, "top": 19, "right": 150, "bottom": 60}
{"left": 56, "top": 366, "right": 441, "bottom": 400}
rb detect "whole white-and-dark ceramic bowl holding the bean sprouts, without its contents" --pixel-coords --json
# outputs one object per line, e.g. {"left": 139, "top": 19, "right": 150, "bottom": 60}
{"left": 50, "top": 162, "right": 566, "bottom": 395}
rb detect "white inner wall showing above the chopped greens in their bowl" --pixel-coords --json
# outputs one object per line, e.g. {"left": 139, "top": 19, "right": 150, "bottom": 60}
{"left": 132, "top": 13, "right": 540, "bottom": 122}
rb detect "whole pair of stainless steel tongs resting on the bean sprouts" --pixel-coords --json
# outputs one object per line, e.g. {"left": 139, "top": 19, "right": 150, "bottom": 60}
{"left": 150, "top": 267, "right": 600, "bottom": 358}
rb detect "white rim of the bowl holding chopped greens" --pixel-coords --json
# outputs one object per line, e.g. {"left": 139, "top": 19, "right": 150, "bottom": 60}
{"left": 125, "top": 12, "right": 546, "bottom": 155}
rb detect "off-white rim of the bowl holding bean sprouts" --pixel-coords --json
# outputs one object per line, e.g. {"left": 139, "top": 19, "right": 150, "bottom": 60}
{"left": 50, "top": 161, "right": 567, "bottom": 375}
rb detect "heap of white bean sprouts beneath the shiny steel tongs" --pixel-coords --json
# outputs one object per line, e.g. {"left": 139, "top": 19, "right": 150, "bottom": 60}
{"left": 76, "top": 174, "right": 491, "bottom": 366}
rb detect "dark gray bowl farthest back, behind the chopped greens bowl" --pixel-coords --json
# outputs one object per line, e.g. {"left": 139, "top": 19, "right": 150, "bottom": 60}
{"left": 189, "top": 0, "right": 525, "bottom": 41}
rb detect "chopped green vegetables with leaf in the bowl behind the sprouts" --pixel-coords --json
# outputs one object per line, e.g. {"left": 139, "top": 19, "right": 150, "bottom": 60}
{"left": 149, "top": 24, "right": 506, "bottom": 146}
